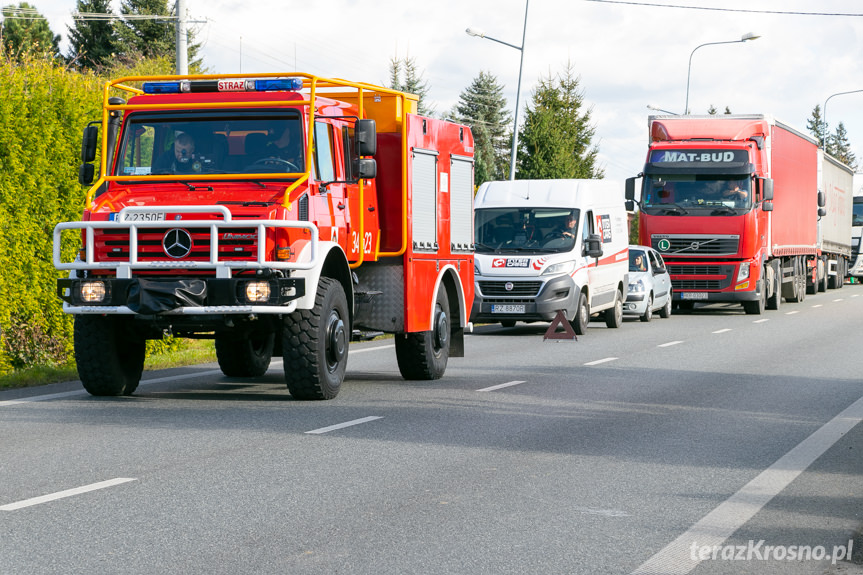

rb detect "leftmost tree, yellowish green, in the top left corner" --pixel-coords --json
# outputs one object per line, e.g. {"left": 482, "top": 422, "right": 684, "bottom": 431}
{"left": 0, "top": 2, "right": 60, "bottom": 61}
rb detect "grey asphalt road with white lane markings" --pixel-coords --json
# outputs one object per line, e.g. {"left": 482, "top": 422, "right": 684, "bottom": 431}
{"left": 0, "top": 286, "right": 863, "bottom": 575}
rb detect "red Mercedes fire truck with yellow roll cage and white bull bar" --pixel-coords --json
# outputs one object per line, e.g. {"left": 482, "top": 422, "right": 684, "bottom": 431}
{"left": 54, "top": 74, "right": 474, "bottom": 399}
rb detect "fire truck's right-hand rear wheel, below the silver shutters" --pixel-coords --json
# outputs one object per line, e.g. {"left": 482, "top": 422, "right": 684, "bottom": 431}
{"left": 395, "top": 286, "right": 450, "bottom": 380}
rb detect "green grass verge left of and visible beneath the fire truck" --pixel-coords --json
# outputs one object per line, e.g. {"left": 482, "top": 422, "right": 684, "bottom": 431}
{"left": 0, "top": 340, "right": 216, "bottom": 390}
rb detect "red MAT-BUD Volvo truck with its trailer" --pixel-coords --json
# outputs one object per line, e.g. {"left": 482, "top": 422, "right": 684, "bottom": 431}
{"left": 626, "top": 115, "right": 852, "bottom": 314}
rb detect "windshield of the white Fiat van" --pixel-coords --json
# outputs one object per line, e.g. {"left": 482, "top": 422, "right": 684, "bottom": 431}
{"left": 475, "top": 208, "right": 579, "bottom": 253}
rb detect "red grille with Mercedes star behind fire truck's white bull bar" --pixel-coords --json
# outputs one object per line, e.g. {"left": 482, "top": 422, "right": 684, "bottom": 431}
{"left": 94, "top": 228, "right": 258, "bottom": 262}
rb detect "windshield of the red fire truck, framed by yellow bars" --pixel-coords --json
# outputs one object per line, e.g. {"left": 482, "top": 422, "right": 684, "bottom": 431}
{"left": 114, "top": 109, "right": 305, "bottom": 176}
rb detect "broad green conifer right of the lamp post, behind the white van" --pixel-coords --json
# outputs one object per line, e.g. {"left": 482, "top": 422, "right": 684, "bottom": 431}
{"left": 518, "top": 63, "right": 603, "bottom": 179}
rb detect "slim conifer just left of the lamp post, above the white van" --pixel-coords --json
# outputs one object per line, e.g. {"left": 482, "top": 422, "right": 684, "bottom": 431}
{"left": 455, "top": 72, "right": 512, "bottom": 186}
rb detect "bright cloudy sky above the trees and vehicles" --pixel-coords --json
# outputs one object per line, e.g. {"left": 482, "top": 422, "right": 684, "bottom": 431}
{"left": 37, "top": 0, "right": 863, "bottom": 178}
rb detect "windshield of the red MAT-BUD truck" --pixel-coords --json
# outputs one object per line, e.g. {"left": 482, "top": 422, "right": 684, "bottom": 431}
{"left": 641, "top": 175, "right": 752, "bottom": 216}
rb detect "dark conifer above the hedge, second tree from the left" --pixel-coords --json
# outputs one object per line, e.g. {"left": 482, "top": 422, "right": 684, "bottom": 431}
{"left": 66, "top": 0, "right": 118, "bottom": 71}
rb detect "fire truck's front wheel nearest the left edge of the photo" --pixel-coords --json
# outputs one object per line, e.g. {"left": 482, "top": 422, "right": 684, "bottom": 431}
{"left": 75, "top": 315, "right": 145, "bottom": 395}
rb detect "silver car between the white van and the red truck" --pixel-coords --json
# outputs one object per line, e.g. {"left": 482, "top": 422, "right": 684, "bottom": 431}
{"left": 623, "top": 246, "right": 671, "bottom": 321}
